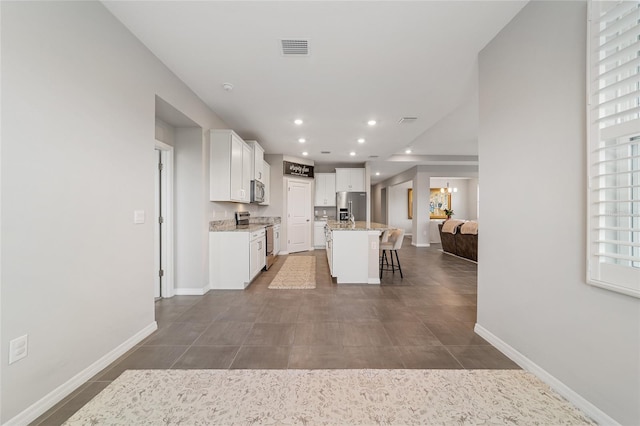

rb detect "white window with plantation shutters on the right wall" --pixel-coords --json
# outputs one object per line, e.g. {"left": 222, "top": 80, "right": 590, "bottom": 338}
{"left": 587, "top": 0, "right": 640, "bottom": 298}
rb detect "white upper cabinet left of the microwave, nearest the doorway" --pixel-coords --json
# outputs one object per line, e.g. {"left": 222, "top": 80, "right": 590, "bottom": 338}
{"left": 209, "top": 130, "right": 253, "bottom": 203}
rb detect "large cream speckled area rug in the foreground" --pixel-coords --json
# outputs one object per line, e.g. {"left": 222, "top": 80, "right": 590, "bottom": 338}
{"left": 65, "top": 370, "right": 595, "bottom": 425}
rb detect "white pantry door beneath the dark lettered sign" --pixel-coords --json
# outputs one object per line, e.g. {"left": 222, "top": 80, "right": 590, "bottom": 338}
{"left": 287, "top": 180, "right": 312, "bottom": 253}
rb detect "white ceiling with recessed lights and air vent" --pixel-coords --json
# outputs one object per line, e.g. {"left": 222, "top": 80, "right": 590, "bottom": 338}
{"left": 103, "top": 0, "right": 526, "bottom": 183}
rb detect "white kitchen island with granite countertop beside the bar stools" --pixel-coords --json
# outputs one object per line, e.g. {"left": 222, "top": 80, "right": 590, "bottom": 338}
{"left": 326, "top": 221, "right": 393, "bottom": 284}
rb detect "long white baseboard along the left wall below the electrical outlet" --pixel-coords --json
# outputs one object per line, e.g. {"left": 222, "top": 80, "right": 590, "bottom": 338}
{"left": 5, "top": 321, "right": 158, "bottom": 426}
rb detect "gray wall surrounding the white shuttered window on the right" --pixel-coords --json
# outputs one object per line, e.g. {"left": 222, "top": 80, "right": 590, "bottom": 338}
{"left": 478, "top": 1, "right": 640, "bottom": 425}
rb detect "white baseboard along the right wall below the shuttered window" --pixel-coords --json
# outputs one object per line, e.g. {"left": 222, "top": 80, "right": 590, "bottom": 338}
{"left": 474, "top": 323, "right": 619, "bottom": 425}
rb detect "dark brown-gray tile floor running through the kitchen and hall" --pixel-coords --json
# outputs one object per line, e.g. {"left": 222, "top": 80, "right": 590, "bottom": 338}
{"left": 33, "top": 238, "right": 519, "bottom": 425}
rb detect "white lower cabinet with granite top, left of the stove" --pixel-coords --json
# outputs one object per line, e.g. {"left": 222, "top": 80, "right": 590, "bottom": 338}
{"left": 209, "top": 228, "right": 266, "bottom": 290}
